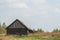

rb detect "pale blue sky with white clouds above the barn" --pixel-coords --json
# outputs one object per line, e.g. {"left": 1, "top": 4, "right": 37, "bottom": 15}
{"left": 0, "top": 0, "right": 60, "bottom": 31}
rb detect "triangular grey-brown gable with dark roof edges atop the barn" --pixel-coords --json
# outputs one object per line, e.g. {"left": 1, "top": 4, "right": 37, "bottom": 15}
{"left": 7, "top": 19, "right": 28, "bottom": 29}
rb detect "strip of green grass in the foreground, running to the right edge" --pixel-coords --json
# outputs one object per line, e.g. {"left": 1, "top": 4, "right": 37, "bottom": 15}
{"left": 15, "top": 35, "right": 60, "bottom": 40}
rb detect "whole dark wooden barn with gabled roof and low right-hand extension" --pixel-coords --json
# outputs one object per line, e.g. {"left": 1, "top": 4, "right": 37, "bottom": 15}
{"left": 6, "top": 19, "right": 33, "bottom": 35}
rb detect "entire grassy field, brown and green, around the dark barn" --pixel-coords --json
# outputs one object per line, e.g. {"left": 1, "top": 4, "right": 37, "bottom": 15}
{"left": 0, "top": 33, "right": 60, "bottom": 40}
